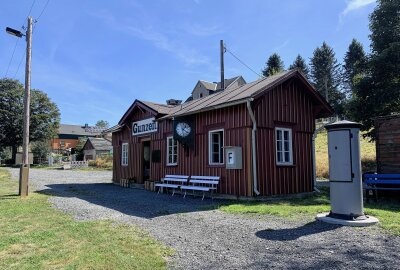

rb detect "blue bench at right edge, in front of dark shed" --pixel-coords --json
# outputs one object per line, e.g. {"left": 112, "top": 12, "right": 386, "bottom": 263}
{"left": 363, "top": 173, "right": 400, "bottom": 201}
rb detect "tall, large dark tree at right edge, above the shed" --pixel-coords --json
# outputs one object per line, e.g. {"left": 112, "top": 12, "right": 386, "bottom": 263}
{"left": 349, "top": 0, "right": 400, "bottom": 139}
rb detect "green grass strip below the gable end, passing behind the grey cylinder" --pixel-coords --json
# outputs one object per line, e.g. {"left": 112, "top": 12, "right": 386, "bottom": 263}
{"left": 219, "top": 188, "right": 400, "bottom": 236}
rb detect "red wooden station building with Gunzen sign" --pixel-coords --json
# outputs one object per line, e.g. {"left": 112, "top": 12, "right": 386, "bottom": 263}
{"left": 112, "top": 71, "right": 333, "bottom": 196}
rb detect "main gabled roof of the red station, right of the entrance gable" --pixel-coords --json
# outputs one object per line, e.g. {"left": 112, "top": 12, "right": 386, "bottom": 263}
{"left": 162, "top": 70, "right": 333, "bottom": 118}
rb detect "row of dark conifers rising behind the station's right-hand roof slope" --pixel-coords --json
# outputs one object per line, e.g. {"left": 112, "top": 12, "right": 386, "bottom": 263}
{"left": 262, "top": 0, "right": 400, "bottom": 139}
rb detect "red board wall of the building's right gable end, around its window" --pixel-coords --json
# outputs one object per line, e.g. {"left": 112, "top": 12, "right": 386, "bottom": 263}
{"left": 255, "top": 80, "right": 315, "bottom": 196}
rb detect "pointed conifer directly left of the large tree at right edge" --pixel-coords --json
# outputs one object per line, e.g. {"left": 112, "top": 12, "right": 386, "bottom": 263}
{"left": 343, "top": 39, "right": 367, "bottom": 96}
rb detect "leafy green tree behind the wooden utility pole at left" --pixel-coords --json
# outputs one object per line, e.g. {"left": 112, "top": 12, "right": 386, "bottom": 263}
{"left": 0, "top": 78, "right": 60, "bottom": 159}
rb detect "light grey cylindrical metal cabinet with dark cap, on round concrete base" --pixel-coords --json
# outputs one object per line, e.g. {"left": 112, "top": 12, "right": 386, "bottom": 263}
{"left": 325, "top": 120, "right": 366, "bottom": 220}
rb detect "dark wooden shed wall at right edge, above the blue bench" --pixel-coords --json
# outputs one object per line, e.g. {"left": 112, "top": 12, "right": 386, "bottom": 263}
{"left": 375, "top": 116, "right": 400, "bottom": 173}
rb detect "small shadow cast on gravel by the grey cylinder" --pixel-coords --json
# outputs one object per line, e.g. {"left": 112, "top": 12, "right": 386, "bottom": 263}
{"left": 256, "top": 221, "right": 342, "bottom": 241}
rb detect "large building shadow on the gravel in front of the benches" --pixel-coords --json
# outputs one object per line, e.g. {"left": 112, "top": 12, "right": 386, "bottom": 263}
{"left": 37, "top": 183, "right": 220, "bottom": 219}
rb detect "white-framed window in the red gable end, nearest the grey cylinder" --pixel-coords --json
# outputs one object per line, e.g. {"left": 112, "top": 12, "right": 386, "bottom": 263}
{"left": 275, "top": 128, "right": 293, "bottom": 165}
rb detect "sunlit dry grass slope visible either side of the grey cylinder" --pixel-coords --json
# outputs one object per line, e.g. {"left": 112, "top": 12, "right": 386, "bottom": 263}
{"left": 315, "top": 130, "right": 376, "bottom": 178}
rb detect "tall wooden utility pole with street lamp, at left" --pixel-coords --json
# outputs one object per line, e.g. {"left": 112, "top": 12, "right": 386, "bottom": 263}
{"left": 19, "top": 16, "right": 32, "bottom": 197}
